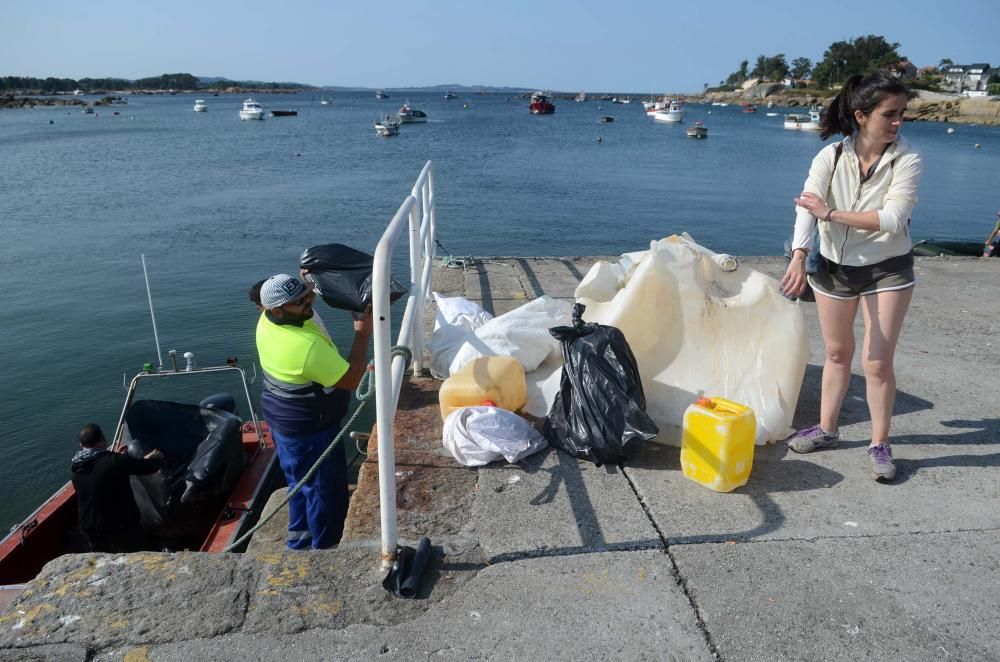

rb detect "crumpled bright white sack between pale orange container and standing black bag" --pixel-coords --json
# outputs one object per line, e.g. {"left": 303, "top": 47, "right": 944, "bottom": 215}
{"left": 448, "top": 296, "right": 573, "bottom": 375}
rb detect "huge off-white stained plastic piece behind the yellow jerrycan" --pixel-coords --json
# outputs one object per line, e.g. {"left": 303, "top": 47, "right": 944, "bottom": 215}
{"left": 576, "top": 235, "right": 809, "bottom": 444}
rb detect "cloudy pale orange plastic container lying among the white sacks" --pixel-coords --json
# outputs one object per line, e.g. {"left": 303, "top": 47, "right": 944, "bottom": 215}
{"left": 438, "top": 356, "right": 528, "bottom": 420}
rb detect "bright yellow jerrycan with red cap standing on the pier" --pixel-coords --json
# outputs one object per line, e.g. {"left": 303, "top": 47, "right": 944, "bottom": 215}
{"left": 681, "top": 398, "right": 757, "bottom": 492}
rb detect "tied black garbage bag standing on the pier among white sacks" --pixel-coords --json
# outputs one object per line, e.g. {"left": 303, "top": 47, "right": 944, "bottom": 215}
{"left": 542, "top": 303, "right": 660, "bottom": 466}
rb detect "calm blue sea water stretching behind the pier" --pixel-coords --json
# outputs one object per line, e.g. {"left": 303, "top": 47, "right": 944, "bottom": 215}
{"left": 0, "top": 93, "right": 1000, "bottom": 529}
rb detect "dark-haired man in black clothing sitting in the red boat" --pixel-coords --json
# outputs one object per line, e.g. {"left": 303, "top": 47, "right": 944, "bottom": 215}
{"left": 70, "top": 423, "right": 163, "bottom": 552}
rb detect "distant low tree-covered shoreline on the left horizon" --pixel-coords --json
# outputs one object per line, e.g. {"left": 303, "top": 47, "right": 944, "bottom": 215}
{"left": 0, "top": 74, "right": 309, "bottom": 94}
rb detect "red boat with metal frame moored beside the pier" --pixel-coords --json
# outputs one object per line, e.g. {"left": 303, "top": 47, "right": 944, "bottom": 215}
{"left": 0, "top": 353, "right": 284, "bottom": 597}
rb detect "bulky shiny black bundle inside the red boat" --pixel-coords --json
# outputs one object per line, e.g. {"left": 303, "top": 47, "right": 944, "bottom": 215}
{"left": 125, "top": 400, "right": 246, "bottom": 534}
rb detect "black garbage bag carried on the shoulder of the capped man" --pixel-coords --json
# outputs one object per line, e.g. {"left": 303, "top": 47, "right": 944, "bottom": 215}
{"left": 299, "top": 244, "right": 406, "bottom": 313}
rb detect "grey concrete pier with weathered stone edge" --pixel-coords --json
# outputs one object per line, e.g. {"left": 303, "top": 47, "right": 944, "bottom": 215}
{"left": 0, "top": 257, "right": 1000, "bottom": 662}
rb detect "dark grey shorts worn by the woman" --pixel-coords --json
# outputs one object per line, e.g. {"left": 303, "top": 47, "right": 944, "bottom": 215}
{"left": 808, "top": 253, "right": 914, "bottom": 299}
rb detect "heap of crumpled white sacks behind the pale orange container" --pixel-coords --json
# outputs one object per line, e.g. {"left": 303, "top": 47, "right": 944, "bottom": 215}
{"left": 428, "top": 295, "right": 573, "bottom": 379}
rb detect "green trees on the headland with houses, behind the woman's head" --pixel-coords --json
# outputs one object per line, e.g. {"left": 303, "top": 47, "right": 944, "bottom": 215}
{"left": 706, "top": 34, "right": 951, "bottom": 90}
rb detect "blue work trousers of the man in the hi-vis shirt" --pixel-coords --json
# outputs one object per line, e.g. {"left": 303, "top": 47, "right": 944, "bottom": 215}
{"left": 271, "top": 425, "right": 347, "bottom": 549}
